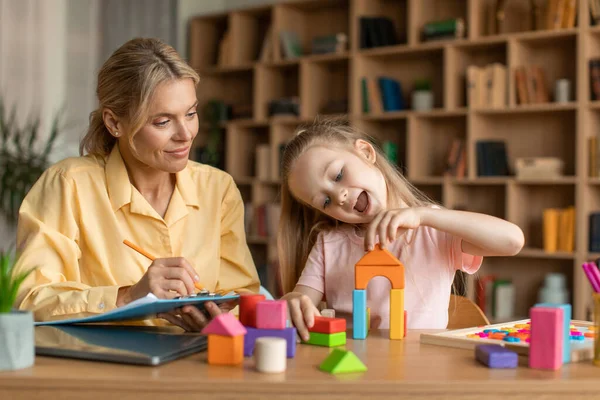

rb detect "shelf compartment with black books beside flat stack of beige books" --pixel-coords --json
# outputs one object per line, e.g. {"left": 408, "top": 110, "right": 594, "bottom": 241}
{"left": 469, "top": 109, "right": 577, "bottom": 177}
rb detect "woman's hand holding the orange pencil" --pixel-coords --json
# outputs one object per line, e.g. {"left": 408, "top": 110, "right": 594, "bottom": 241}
{"left": 117, "top": 257, "right": 200, "bottom": 306}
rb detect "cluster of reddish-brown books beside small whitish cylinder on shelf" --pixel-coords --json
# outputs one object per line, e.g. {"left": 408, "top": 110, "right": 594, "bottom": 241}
{"left": 514, "top": 65, "right": 550, "bottom": 104}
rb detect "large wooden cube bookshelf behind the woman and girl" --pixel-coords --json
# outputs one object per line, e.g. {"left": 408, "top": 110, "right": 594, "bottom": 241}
{"left": 190, "top": 0, "right": 600, "bottom": 319}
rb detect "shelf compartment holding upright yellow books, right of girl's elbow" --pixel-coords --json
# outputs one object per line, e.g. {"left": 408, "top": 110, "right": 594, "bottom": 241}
{"left": 507, "top": 183, "right": 577, "bottom": 251}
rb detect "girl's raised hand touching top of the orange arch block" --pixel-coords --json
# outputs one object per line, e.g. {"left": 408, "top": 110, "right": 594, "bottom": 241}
{"left": 365, "top": 207, "right": 421, "bottom": 251}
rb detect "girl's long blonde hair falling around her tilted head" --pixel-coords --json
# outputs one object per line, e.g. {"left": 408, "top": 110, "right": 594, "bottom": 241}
{"left": 277, "top": 115, "right": 434, "bottom": 293}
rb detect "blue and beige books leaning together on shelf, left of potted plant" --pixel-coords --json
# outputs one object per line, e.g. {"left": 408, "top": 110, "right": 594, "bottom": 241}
{"left": 361, "top": 76, "right": 406, "bottom": 114}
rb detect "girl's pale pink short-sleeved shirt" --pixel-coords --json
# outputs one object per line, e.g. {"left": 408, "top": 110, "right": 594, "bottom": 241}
{"left": 298, "top": 226, "right": 483, "bottom": 329}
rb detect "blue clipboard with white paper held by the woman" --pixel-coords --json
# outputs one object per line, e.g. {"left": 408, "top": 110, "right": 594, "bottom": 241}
{"left": 35, "top": 293, "right": 239, "bottom": 325}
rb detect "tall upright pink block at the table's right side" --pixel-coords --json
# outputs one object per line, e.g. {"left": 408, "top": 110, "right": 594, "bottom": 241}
{"left": 529, "top": 307, "right": 563, "bottom": 370}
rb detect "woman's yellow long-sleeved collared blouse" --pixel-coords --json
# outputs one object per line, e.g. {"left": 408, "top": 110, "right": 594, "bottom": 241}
{"left": 16, "top": 146, "right": 259, "bottom": 321}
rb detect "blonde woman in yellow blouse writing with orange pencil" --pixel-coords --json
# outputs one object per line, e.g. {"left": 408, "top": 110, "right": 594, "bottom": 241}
{"left": 12, "top": 39, "right": 259, "bottom": 331}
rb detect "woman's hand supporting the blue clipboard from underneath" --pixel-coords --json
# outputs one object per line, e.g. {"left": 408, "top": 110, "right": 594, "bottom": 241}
{"left": 157, "top": 301, "right": 237, "bottom": 332}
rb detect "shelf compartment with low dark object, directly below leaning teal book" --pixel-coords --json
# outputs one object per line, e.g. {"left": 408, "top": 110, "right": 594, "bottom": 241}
{"left": 254, "top": 64, "right": 301, "bottom": 120}
